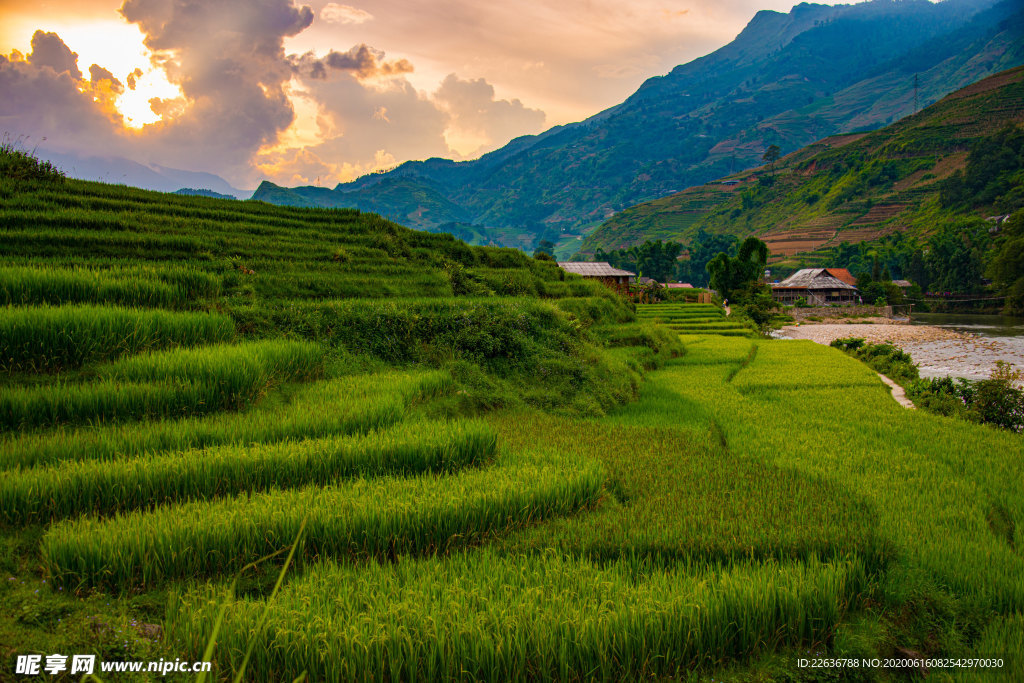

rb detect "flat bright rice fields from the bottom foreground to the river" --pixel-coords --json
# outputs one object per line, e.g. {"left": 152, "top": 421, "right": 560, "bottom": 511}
{"left": 167, "top": 323, "right": 1024, "bottom": 681}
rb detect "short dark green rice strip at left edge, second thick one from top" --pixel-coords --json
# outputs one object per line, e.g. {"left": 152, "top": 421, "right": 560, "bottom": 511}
{"left": 0, "top": 305, "right": 234, "bottom": 373}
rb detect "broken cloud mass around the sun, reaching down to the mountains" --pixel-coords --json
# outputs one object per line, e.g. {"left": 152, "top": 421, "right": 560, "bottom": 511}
{"left": 0, "top": 0, "right": 545, "bottom": 186}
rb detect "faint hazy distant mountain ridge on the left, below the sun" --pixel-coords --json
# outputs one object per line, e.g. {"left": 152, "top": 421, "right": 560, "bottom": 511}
{"left": 36, "top": 148, "right": 249, "bottom": 199}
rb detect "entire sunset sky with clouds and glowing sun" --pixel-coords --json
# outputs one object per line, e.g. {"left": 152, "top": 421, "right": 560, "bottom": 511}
{"left": 0, "top": 0, "right": 831, "bottom": 188}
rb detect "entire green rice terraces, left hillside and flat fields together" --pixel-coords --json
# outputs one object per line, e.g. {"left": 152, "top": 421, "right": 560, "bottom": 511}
{"left": 0, "top": 162, "right": 1024, "bottom": 681}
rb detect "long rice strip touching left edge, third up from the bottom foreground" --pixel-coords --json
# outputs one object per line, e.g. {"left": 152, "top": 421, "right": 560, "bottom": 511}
{"left": 0, "top": 422, "right": 496, "bottom": 524}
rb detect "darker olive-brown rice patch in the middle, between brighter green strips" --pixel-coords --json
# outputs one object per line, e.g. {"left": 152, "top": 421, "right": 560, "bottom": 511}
{"left": 492, "top": 411, "right": 892, "bottom": 569}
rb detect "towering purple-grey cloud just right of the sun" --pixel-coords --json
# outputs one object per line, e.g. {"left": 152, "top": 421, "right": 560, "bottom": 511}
{"left": 114, "top": 0, "right": 313, "bottom": 176}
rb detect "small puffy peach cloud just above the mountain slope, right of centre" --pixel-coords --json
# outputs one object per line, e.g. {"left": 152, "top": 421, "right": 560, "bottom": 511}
{"left": 433, "top": 74, "right": 545, "bottom": 157}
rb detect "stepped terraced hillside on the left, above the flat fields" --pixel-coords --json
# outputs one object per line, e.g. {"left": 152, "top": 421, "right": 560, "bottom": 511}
{"left": 0, "top": 161, "right": 681, "bottom": 678}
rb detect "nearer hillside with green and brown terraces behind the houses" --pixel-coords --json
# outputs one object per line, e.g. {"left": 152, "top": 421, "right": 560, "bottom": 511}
{"left": 581, "top": 67, "right": 1024, "bottom": 263}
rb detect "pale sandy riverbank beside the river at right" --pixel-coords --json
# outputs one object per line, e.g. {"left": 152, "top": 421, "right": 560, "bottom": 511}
{"left": 779, "top": 321, "right": 1024, "bottom": 379}
